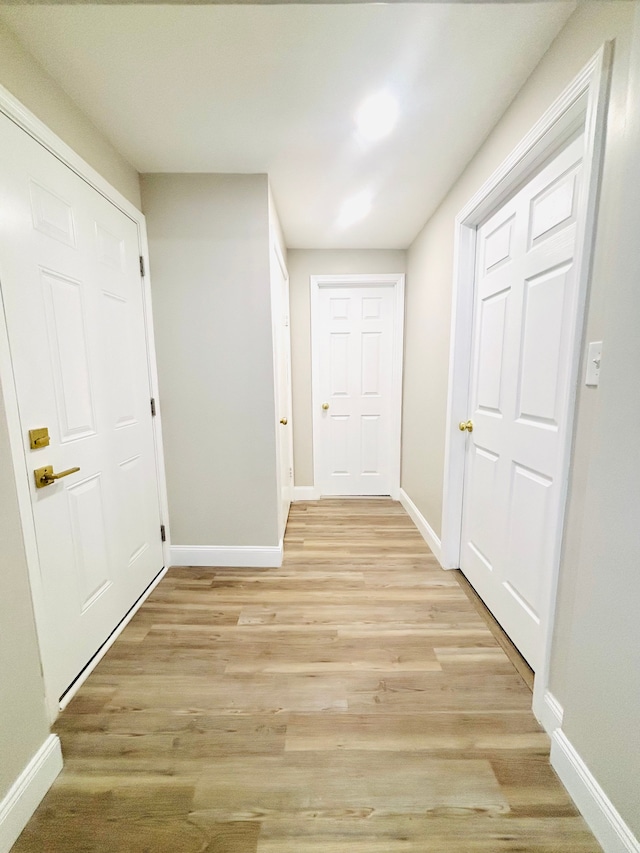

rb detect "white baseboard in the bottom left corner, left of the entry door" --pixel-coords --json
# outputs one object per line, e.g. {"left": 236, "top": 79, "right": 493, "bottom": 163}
{"left": 0, "top": 735, "right": 62, "bottom": 853}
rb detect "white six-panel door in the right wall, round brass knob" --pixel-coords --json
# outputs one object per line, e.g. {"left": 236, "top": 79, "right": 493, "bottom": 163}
{"left": 460, "top": 137, "right": 583, "bottom": 670}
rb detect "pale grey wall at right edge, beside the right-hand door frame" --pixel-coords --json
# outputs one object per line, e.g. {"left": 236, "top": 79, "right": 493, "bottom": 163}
{"left": 552, "top": 3, "right": 640, "bottom": 842}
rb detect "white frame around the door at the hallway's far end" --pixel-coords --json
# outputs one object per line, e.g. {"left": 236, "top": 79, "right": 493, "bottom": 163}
{"left": 310, "top": 273, "right": 404, "bottom": 501}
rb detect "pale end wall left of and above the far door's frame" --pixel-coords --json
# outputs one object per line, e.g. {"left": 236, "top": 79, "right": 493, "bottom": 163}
{"left": 287, "top": 249, "right": 406, "bottom": 486}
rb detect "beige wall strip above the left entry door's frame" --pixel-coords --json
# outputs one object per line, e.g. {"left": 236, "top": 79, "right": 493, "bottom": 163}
{"left": 0, "top": 22, "right": 140, "bottom": 208}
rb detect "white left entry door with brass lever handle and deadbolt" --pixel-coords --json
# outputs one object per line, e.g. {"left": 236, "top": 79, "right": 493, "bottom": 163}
{"left": 0, "top": 111, "right": 163, "bottom": 696}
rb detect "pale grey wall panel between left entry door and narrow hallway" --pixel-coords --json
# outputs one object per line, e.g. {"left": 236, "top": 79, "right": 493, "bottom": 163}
{"left": 141, "top": 174, "right": 278, "bottom": 547}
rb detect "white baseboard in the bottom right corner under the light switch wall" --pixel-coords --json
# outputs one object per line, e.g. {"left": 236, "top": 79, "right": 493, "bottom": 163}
{"left": 551, "top": 729, "right": 640, "bottom": 853}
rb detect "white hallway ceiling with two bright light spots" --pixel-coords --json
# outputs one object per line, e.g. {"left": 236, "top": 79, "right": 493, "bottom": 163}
{"left": 0, "top": 2, "right": 575, "bottom": 248}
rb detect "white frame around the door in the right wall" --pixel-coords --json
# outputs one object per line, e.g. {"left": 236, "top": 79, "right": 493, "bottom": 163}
{"left": 441, "top": 42, "right": 613, "bottom": 722}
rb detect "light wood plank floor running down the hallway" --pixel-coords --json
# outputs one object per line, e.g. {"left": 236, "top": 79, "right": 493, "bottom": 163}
{"left": 14, "top": 500, "right": 600, "bottom": 853}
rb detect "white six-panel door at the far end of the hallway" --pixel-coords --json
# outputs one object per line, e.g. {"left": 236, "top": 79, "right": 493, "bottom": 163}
{"left": 313, "top": 277, "right": 401, "bottom": 495}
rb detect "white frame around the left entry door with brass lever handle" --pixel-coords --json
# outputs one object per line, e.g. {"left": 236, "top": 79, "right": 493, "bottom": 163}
{"left": 0, "top": 86, "right": 171, "bottom": 722}
